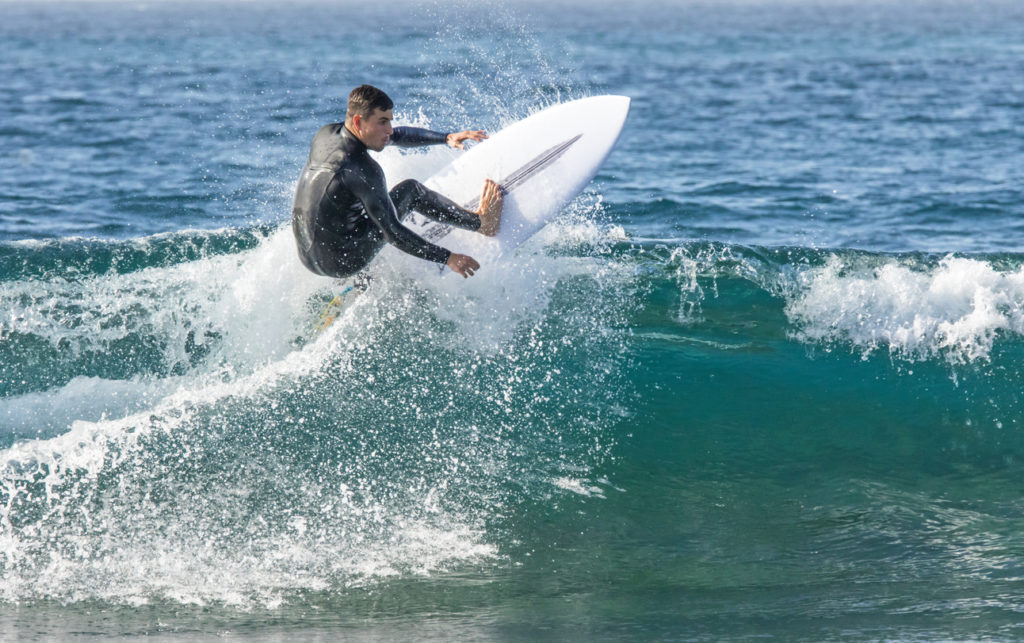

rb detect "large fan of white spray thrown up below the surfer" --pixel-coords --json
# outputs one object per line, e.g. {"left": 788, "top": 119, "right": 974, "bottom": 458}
{"left": 0, "top": 201, "right": 630, "bottom": 605}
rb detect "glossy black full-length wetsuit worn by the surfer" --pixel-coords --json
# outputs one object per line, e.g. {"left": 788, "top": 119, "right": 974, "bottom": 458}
{"left": 292, "top": 123, "right": 480, "bottom": 276}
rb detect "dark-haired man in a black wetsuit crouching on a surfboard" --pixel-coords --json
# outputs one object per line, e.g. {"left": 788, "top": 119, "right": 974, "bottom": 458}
{"left": 292, "top": 85, "right": 502, "bottom": 277}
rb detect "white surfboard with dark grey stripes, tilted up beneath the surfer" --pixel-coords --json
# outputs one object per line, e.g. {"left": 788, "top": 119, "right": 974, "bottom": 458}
{"left": 382, "top": 95, "right": 630, "bottom": 274}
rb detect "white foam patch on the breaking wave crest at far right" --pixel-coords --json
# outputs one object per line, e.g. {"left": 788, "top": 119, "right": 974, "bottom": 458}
{"left": 785, "top": 255, "right": 1024, "bottom": 363}
